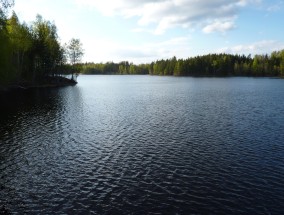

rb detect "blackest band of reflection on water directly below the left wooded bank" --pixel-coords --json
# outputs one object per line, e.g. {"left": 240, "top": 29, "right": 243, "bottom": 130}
{"left": 0, "top": 86, "right": 80, "bottom": 127}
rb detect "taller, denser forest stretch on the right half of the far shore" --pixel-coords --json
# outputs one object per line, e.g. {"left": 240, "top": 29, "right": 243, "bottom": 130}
{"left": 149, "top": 50, "right": 284, "bottom": 76}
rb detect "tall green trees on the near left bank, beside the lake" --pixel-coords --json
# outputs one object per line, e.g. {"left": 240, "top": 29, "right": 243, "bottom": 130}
{"left": 0, "top": 0, "right": 83, "bottom": 85}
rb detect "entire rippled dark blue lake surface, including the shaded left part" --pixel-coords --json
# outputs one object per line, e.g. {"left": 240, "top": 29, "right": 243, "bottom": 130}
{"left": 0, "top": 76, "right": 284, "bottom": 214}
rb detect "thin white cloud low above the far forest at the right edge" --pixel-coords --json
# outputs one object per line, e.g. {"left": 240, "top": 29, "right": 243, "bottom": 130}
{"left": 217, "top": 40, "right": 284, "bottom": 55}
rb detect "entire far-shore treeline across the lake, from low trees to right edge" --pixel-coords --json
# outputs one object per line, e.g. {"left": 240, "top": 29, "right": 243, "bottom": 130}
{"left": 81, "top": 50, "right": 284, "bottom": 76}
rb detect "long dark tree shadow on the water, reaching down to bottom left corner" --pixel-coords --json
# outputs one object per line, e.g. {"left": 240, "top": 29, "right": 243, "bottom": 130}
{"left": 0, "top": 86, "right": 81, "bottom": 214}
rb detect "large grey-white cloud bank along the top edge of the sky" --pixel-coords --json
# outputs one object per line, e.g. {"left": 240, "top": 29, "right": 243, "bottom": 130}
{"left": 76, "top": 0, "right": 261, "bottom": 34}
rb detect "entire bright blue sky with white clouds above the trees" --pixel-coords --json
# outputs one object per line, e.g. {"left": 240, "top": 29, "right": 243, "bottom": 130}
{"left": 13, "top": 0, "right": 284, "bottom": 64}
